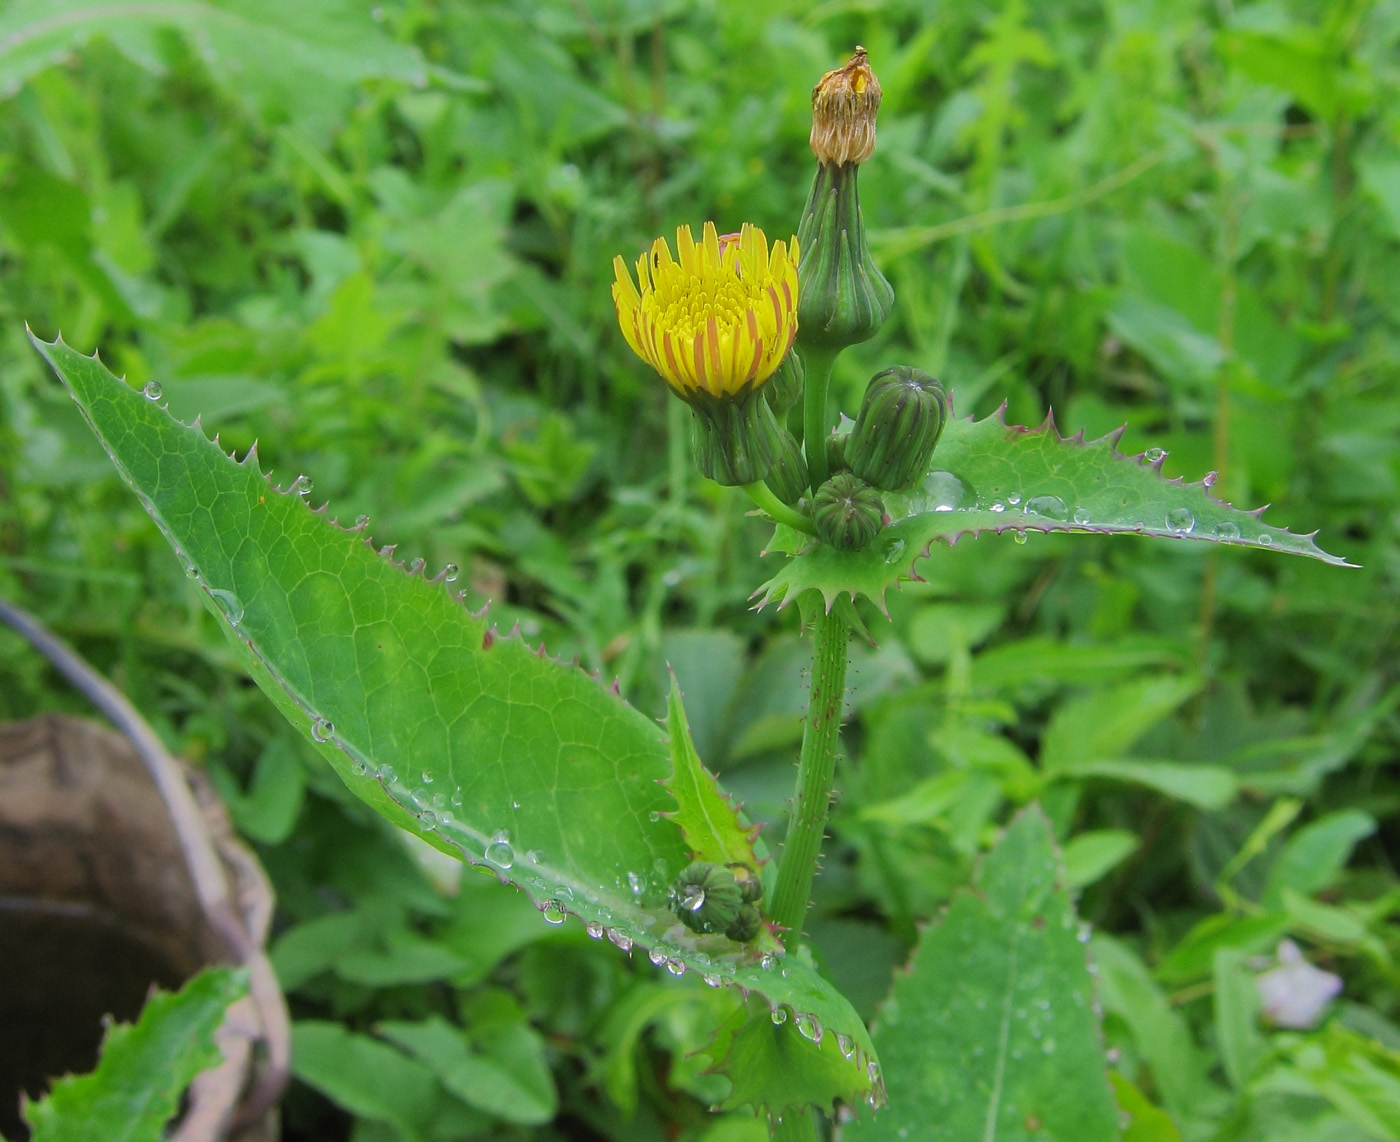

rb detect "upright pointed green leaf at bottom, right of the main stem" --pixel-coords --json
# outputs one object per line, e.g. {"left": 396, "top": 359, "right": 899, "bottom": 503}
{"left": 843, "top": 809, "right": 1119, "bottom": 1142}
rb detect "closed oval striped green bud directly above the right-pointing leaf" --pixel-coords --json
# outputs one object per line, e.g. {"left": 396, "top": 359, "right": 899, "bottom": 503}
{"left": 846, "top": 365, "right": 948, "bottom": 491}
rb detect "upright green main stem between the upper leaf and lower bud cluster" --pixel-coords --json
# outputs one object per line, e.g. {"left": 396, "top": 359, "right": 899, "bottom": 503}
{"left": 769, "top": 612, "right": 850, "bottom": 949}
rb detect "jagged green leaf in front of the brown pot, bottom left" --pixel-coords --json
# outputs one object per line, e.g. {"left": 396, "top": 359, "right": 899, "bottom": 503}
{"left": 24, "top": 968, "right": 246, "bottom": 1142}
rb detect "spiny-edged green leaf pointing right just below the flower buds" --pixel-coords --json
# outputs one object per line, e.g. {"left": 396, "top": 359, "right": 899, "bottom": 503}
{"left": 755, "top": 410, "right": 1348, "bottom": 610}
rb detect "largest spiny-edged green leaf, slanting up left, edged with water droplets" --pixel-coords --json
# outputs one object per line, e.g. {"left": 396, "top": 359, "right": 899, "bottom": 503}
{"left": 34, "top": 330, "right": 876, "bottom": 1100}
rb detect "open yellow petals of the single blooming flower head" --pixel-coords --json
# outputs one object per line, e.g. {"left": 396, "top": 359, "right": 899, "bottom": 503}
{"left": 613, "top": 223, "right": 798, "bottom": 397}
